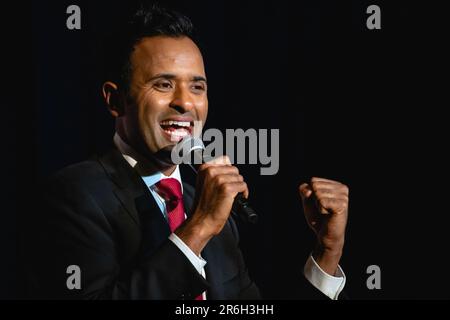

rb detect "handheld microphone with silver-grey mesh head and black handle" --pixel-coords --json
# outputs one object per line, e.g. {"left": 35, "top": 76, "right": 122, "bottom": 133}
{"left": 172, "top": 136, "right": 258, "bottom": 224}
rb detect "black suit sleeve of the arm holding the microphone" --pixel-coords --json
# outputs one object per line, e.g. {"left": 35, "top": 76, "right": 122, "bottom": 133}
{"left": 26, "top": 178, "right": 208, "bottom": 299}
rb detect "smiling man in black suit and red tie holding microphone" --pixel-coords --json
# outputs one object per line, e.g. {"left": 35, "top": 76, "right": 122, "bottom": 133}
{"left": 23, "top": 6, "right": 348, "bottom": 300}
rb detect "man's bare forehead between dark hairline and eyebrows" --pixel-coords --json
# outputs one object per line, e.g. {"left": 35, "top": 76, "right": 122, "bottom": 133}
{"left": 130, "top": 36, "right": 205, "bottom": 76}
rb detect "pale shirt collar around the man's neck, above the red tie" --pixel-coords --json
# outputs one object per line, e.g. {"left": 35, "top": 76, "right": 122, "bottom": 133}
{"left": 114, "top": 132, "right": 183, "bottom": 191}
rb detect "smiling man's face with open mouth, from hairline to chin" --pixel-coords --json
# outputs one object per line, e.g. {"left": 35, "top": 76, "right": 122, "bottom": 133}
{"left": 123, "top": 36, "right": 208, "bottom": 155}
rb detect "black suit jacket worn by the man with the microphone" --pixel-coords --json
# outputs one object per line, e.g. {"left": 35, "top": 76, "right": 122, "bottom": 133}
{"left": 25, "top": 149, "right": 334, "bottom": 299}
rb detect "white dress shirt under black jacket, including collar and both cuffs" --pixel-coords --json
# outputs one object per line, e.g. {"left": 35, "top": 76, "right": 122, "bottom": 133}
{"left": 114, "top": 133, "right": 346, "bottom": 300}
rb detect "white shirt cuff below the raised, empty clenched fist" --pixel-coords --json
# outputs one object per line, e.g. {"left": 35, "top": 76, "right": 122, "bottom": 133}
{"left": 303, "top": 255, "right": 346, "bottom": 300}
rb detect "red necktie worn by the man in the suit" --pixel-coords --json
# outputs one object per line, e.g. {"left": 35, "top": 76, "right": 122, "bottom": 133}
{"left": 156, "top": 178, "right": 203, "bottom": 300}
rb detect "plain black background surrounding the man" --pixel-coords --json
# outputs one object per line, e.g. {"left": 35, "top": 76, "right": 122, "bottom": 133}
{"left": 0, "top": 0, "right": 450, "bottom": 299}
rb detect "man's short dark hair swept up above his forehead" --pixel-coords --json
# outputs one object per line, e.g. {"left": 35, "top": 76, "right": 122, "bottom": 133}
{"left": 103, "top": 3, "right": 193, "bottom": 92}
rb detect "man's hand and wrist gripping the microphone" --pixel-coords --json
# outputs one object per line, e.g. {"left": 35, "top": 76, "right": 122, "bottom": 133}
{"left": 175, "top": 156, "right": 248, "bottom": 255}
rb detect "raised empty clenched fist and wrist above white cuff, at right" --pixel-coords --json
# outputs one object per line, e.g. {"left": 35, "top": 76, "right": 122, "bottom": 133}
{"left": 299, "top": 178, "right": 349, "bottom": 274}
